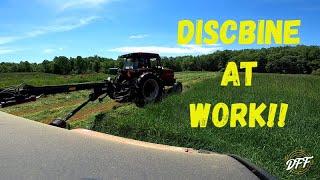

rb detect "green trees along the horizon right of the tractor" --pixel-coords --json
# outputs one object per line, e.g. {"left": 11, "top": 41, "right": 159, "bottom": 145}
{"left": 163, "top": 46, "right": 320, "bottom": 74}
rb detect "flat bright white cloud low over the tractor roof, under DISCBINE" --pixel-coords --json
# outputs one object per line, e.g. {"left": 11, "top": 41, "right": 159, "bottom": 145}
{"left": 109, "top": 45, "right": 222, "bottom": 55}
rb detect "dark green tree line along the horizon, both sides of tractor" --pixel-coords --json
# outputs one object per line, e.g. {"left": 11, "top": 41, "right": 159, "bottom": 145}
{"left": 0, "top": 45, "right": 320, "bottom": 74}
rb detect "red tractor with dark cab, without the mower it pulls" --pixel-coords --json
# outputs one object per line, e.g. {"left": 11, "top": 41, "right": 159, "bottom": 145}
{"left": 108, "top": 53, "right": 182, "bottom": 107}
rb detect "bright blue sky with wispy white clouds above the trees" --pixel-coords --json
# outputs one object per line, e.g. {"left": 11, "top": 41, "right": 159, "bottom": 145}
{"left": 0, "top": 0, "right": 320, "bottom": 62}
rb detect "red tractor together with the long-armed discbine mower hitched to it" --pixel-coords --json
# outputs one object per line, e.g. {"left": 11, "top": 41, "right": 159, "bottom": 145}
{"left": 0, "top": 53, "right": 182, "bottom": 128}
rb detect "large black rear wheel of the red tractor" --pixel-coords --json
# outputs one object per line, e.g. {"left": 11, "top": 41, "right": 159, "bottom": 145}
{"left": 135, "top": 74, "right": 163, "bottom": 107}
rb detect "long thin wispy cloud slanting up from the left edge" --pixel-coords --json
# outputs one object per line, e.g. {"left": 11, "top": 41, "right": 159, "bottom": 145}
{"left": 0, "top": 16, "right": 99, "bottom": 45}
